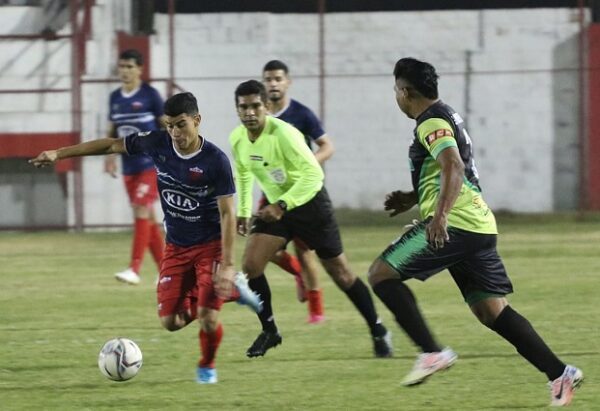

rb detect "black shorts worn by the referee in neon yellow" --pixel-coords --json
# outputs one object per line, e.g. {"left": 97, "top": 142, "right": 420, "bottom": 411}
{"left": 250, "top": 187, "right": 344, "bottom": 259}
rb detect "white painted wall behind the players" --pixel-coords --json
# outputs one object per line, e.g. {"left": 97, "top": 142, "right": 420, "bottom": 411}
{"left": 0, "top": 0, "right": 579, "bottom": 224}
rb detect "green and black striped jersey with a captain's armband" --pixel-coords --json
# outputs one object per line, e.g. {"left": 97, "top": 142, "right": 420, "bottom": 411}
{"left": 409, "top": 100, "right": 498, "bottom": 234}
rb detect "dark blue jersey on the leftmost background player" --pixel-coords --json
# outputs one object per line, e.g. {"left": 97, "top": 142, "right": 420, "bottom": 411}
{"left": 109, "top": 83, "right": 163, "bottom": 175}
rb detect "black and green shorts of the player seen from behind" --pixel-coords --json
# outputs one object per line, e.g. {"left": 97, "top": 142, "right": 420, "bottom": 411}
{"left": 379, "top": 220, "right": 513, "bottom": 304}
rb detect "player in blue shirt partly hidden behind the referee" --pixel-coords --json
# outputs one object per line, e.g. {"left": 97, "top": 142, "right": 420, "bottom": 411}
{"left": 262, "top": 60, "right": 334, "bottom": 324}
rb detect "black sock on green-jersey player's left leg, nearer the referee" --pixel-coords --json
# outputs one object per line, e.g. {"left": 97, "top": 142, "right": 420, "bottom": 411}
{"left": 373, "top": 279, "right": 441, "bottom": 352}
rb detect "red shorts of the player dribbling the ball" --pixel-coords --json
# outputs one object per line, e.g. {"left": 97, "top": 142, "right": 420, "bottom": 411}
{"left": 156, "top": 240, "right": 224, "bottom": 317}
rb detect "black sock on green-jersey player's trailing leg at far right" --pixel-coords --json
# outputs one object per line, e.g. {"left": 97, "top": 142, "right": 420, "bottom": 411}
{"left": 491, "top": 305, "right": 565, "bottom": 381}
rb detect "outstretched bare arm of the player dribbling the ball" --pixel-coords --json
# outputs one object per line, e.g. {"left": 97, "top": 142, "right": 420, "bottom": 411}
{"left": 29, "top": 138, "right": 127, "bottom": 167}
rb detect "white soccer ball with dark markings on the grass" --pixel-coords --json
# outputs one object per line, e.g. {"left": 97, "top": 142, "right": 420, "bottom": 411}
{"left": 98, "top": 338, "right": 142, "bottom": 381}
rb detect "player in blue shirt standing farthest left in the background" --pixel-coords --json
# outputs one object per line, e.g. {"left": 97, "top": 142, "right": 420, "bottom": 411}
{"left": 104, "top": 50, "right": 164, "bottom": 284}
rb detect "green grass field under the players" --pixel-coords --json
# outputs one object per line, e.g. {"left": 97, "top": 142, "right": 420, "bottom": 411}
{"left": 0, "top": 212, "right": 600, "bottom": 411}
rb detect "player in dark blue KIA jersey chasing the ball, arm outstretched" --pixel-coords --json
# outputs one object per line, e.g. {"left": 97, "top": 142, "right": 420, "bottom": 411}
{"left": 30, "top": 93, "right": 262, "bottom": 384}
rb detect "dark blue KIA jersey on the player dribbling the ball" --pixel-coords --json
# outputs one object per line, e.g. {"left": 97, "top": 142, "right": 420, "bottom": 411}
{"left": 125, "top": 131, "right": 235, "bottom": 247}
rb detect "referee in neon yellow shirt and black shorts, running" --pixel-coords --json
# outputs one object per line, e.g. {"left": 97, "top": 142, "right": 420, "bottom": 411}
{"left": 229, "top": 80, "right": 392, "bottom": 357}
